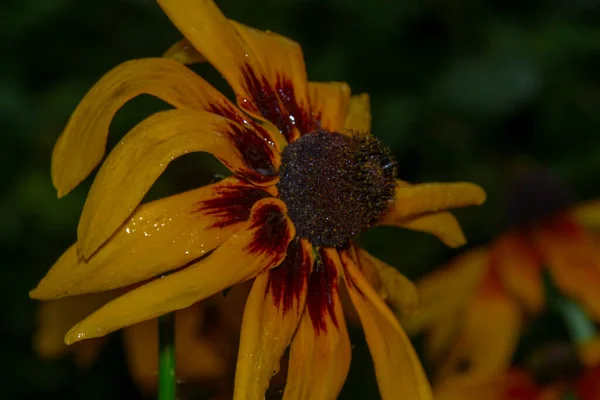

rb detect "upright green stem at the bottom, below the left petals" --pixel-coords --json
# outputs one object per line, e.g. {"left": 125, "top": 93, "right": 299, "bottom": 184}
{"left": 158, "top": 313, "right": 176, "bottom": 400}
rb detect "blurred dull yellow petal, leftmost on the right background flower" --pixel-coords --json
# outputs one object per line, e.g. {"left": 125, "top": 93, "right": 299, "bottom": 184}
{"left": 402, "top": 248, "right": 489, "bottom": 334}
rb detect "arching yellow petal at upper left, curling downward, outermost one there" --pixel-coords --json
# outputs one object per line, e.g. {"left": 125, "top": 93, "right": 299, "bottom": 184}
{"left": 52, "top": 58, "right": 243, "bottom": 197}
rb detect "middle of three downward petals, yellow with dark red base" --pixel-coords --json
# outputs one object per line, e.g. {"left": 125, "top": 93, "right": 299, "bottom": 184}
{"left": 283, "top": 249, "right": 351, "bottom": 400}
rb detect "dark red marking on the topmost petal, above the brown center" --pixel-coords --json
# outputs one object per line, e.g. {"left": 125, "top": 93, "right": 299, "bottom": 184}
{"left": 239, "top": 65, "right": 314, "bottom": 142}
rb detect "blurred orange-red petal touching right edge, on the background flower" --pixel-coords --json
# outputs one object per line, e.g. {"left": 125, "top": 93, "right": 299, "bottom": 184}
{"left": 533, "top": 217, "right": 600, "bottom": 321}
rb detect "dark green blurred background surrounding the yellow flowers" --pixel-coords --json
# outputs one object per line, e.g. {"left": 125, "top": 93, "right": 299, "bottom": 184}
{"left": 0, "top": 0, "right": 600, "bottom": 400}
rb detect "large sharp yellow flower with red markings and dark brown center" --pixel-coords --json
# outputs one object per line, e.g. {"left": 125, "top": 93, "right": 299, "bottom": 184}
{"left": 31, "top": 0, "right": 485, "bottom": 399}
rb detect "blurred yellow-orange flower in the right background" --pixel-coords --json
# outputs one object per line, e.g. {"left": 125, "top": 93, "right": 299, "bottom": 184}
{"left": 405, "top": 201, "right": 600, "bottom": 380}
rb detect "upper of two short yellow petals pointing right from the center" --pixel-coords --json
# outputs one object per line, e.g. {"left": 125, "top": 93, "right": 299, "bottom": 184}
{"left": 379, "top": 182, "right": 486, "bottom": 225}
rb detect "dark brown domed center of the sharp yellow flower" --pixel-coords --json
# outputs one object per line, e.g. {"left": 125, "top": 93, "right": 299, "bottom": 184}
{"left": 277, "top": 131, "right": 396, "bottom": 247}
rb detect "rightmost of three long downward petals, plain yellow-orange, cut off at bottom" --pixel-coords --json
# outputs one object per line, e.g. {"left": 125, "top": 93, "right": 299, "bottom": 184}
{"left": 340, "top": 252, "right": 432, "bottom": 400}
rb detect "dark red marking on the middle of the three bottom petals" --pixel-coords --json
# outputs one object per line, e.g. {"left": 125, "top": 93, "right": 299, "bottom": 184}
{"left": 306, "top": 250, "right": 338, "bottom": 334}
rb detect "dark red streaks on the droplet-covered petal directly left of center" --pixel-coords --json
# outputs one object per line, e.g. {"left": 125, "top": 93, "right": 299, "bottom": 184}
{"left": 196, "top": 185, "right": 270, "bottom": 228}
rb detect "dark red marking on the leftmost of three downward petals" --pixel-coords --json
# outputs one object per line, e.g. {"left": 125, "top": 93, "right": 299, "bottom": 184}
{"left": 266, "top": 237, "right": 311, "bottom": 314}
